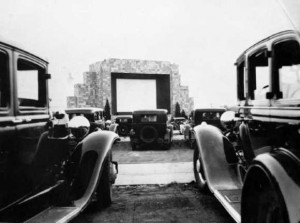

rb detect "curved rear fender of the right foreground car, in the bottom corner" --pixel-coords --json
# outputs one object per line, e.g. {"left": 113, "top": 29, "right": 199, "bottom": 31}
{"left": 250, "top": 149, "right": 300, "bottom": 223}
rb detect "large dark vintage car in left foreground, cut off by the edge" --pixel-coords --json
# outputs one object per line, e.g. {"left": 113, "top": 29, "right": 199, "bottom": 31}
{"left": 0, "top": 43, "right": 118, "bottom": 222}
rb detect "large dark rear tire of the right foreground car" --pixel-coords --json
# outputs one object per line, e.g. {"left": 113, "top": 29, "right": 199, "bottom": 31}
{"left": 241, "top": 168, "right": 289, "bottom": 223}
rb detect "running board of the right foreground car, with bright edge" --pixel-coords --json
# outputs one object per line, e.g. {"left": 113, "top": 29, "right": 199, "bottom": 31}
{"left": 214, "top": 189, "right": 242, "bottom": 223}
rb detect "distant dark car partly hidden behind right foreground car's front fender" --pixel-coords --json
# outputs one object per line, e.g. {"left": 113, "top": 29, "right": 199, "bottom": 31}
{"left": 182, "top": 108, "right": 226, "bottom": 148}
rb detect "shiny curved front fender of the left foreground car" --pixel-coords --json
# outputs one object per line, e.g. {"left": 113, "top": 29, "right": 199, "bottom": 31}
{"left": 74, "top": 131, "right": 119, "bottom": 214}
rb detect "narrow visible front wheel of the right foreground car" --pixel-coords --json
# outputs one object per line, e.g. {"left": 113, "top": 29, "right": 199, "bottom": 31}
{"left": 193, "top": 148, "right": 208, "bottom": 192}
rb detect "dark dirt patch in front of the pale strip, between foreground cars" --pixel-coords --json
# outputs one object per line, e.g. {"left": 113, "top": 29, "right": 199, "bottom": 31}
{"left": 73, "top": 183, "right": 234, "bottom": 223}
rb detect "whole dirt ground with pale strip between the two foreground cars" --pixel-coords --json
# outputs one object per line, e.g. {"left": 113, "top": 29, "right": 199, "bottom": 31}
{"left": 73, "top": 134, "right": 234, "bottom": 223}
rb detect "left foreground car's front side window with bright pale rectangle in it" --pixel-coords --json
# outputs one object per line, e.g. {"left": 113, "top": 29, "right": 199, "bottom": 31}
{"left": 17, "top": 59, "right": 46, "bottom": 110}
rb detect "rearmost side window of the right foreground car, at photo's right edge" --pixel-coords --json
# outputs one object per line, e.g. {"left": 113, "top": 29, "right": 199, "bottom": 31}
{"left": 273, "top": 40, "right": 300, "bottom": 99}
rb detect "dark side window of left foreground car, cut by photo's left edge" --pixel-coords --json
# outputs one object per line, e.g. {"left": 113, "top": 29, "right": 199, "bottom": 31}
{"left": 0, "top": 51, "right": 10, "bottom": 111}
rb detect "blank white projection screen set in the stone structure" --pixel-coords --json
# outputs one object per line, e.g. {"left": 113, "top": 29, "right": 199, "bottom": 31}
{"left": 116, "top": 78, "right": 157, "bottom": 112}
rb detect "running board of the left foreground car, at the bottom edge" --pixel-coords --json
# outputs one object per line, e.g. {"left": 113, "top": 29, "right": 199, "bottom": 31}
{"left": 26, "top": 206, "right": 80, "bottom": 223}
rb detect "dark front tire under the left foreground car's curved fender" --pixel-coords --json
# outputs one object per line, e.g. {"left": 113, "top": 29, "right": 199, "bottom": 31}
{"left": 97, "top": 152, "right": 112, "bottom": 208}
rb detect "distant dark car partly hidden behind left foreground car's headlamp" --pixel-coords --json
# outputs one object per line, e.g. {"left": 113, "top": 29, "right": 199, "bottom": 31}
{"left": 65, "top": 107, "right": 105, "bottom": 132}
